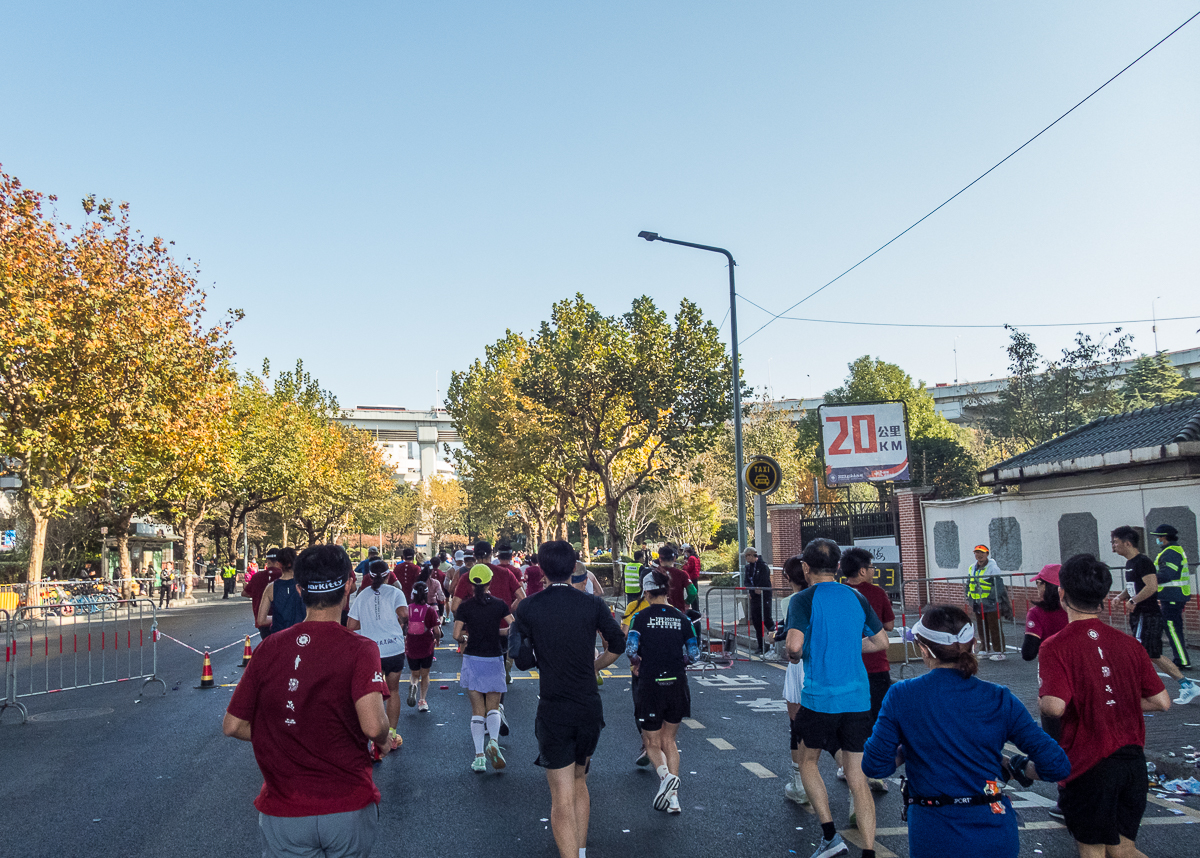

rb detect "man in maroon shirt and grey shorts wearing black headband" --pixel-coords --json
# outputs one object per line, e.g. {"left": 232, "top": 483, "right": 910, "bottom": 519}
{"left": 223, "top": 545, "right": 391, "bottom": 856}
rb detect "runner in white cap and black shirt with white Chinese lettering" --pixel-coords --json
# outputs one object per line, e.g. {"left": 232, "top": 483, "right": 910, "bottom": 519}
{"left": 625, "top": 570, "right": 700, "bottom": 814}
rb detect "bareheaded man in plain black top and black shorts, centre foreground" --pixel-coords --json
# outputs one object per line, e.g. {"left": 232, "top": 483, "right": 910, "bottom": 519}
{"left": 510, "top": 541, "right": 625, "bottom": 858}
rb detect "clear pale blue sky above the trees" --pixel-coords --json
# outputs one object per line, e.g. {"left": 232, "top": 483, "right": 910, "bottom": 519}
{"left": 0, "top": 0, "right": 1200, "bottom": 408}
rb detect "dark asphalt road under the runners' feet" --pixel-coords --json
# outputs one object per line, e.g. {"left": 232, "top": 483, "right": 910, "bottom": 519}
{"left": 0, "top": 600, "right": 1200, "bottom": 858}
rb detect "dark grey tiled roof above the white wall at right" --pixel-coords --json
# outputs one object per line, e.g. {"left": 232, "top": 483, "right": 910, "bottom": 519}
{"left": 988, "top": 396, "right": 1200, "bottom": 472}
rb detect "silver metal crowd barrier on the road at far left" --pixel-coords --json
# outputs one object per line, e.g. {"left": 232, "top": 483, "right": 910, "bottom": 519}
{"left": 0, "top": 599, "right": 167, "bottom": 724}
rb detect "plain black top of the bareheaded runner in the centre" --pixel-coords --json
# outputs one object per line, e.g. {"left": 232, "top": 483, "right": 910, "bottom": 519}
{"left": 514, "top": 584, "right": 625, "bottom": 725}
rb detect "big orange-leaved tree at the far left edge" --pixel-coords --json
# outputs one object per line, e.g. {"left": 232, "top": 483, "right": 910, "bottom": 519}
{"left": 0, "top": 172, "right": 238, "bottom": 581}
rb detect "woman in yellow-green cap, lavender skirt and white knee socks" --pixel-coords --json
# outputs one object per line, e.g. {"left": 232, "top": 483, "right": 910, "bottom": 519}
{"left": 454, "top": 563, "right": 512, "bottom": 772}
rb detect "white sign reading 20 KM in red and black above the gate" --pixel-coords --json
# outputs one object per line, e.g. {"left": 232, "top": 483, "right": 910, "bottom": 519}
{"left": 817, "top": 402, "right": 910, "bottom": 488}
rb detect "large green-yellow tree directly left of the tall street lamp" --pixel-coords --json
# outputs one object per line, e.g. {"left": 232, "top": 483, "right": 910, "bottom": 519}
{"left": 516, "top": 295, "right": 732, "bottom": 566}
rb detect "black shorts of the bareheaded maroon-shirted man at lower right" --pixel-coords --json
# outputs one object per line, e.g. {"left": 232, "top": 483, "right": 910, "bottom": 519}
{"left": 1058, "top": 745, "right": 1150, "bottom": 846}
